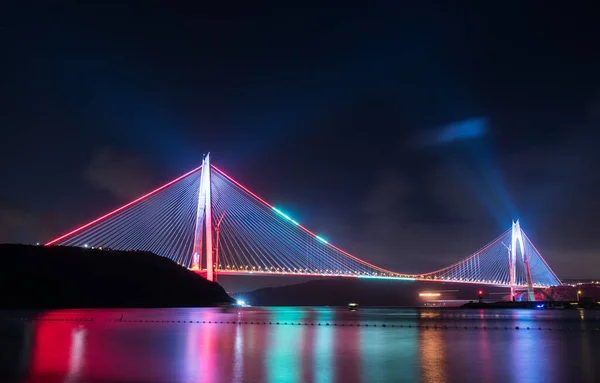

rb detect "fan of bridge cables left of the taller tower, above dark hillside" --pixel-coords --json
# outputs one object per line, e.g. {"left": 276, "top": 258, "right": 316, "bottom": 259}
{"left": 47, "top": 169, "right": 200, "bottom": 267}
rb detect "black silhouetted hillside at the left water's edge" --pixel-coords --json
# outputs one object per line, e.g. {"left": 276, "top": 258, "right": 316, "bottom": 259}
{"left": 0, "top": 245, "right": 232, "bottom": 308}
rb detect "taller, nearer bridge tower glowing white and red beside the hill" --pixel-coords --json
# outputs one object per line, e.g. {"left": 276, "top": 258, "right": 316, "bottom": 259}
{"left": 192, "top": 153, "right": 214, "bottom": 281}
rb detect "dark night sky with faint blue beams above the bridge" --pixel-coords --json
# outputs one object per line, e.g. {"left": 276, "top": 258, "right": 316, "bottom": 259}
{"left": 0, "top": 1, "right": 600, "bottom": 278}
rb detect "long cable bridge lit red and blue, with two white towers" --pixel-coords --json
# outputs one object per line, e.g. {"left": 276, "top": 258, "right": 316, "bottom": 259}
{"left": 45, "top": 155, "right": 561, "bottom": 300}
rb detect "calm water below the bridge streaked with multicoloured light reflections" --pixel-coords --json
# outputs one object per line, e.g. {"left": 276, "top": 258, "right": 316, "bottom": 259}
{"left": 0, "top": 307, "right": 600, "bottom": 383}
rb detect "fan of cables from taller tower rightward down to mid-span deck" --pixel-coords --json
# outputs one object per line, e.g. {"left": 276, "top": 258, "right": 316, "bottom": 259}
{"left": 211, "top": 168, "right": 400, "bottom": 277}
